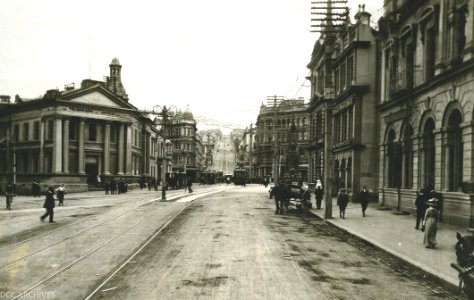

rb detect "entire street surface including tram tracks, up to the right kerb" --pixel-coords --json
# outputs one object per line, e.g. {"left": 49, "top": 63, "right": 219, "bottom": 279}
{"left": 0, "top": 184, "right": 458, "bottom": 299}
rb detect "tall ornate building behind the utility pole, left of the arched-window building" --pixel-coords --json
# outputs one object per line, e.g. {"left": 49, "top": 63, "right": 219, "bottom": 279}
{"left": 308, "top": 9, "right": 378, "bottom": 194}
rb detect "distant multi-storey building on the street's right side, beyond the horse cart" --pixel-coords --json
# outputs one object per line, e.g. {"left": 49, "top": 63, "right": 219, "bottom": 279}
{"left": 253, "top": 97, "right": 309, "bottom": 181}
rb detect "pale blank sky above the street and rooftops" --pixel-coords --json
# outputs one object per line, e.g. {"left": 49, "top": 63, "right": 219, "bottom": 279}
{"left": 0, "top": 0, "right": 383, "bottom": 129}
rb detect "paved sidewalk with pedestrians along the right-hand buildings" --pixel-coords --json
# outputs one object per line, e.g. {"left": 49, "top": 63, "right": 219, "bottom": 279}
{"left": 311, "top": 199, "right": 462, "bottom": 287}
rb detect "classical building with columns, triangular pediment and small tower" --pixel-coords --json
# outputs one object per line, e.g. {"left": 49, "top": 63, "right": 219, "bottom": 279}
{"left": 0, "top": 58, "right": 160, "bottom": 193}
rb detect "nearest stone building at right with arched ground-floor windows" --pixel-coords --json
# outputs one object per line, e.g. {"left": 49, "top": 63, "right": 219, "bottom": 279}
{"left": 378, "top": 0, "right": 474, "bottom": 226}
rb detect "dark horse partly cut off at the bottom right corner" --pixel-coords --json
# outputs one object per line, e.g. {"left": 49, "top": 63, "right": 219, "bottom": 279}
{"left": 451, "top": 232, "right": 474, "bottom": 300}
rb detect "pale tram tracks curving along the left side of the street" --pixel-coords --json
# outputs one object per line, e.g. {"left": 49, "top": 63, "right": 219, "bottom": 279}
{"left": 4, "top": 189, "right": 228, "bottom": 299}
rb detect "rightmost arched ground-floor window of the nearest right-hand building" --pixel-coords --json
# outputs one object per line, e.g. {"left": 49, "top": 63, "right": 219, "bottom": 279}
{"left": 447, "top": 110, "right": 463, "bottom": 191}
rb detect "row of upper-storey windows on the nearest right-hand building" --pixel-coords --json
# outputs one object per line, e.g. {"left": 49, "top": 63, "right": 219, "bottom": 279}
{"left": 383, "top": 1, "right": 467, "bottom": 99}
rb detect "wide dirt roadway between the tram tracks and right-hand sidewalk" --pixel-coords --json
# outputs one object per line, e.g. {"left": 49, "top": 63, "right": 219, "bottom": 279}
{"left": 92, "top": 186, "right": 455, "bottom": 300}
